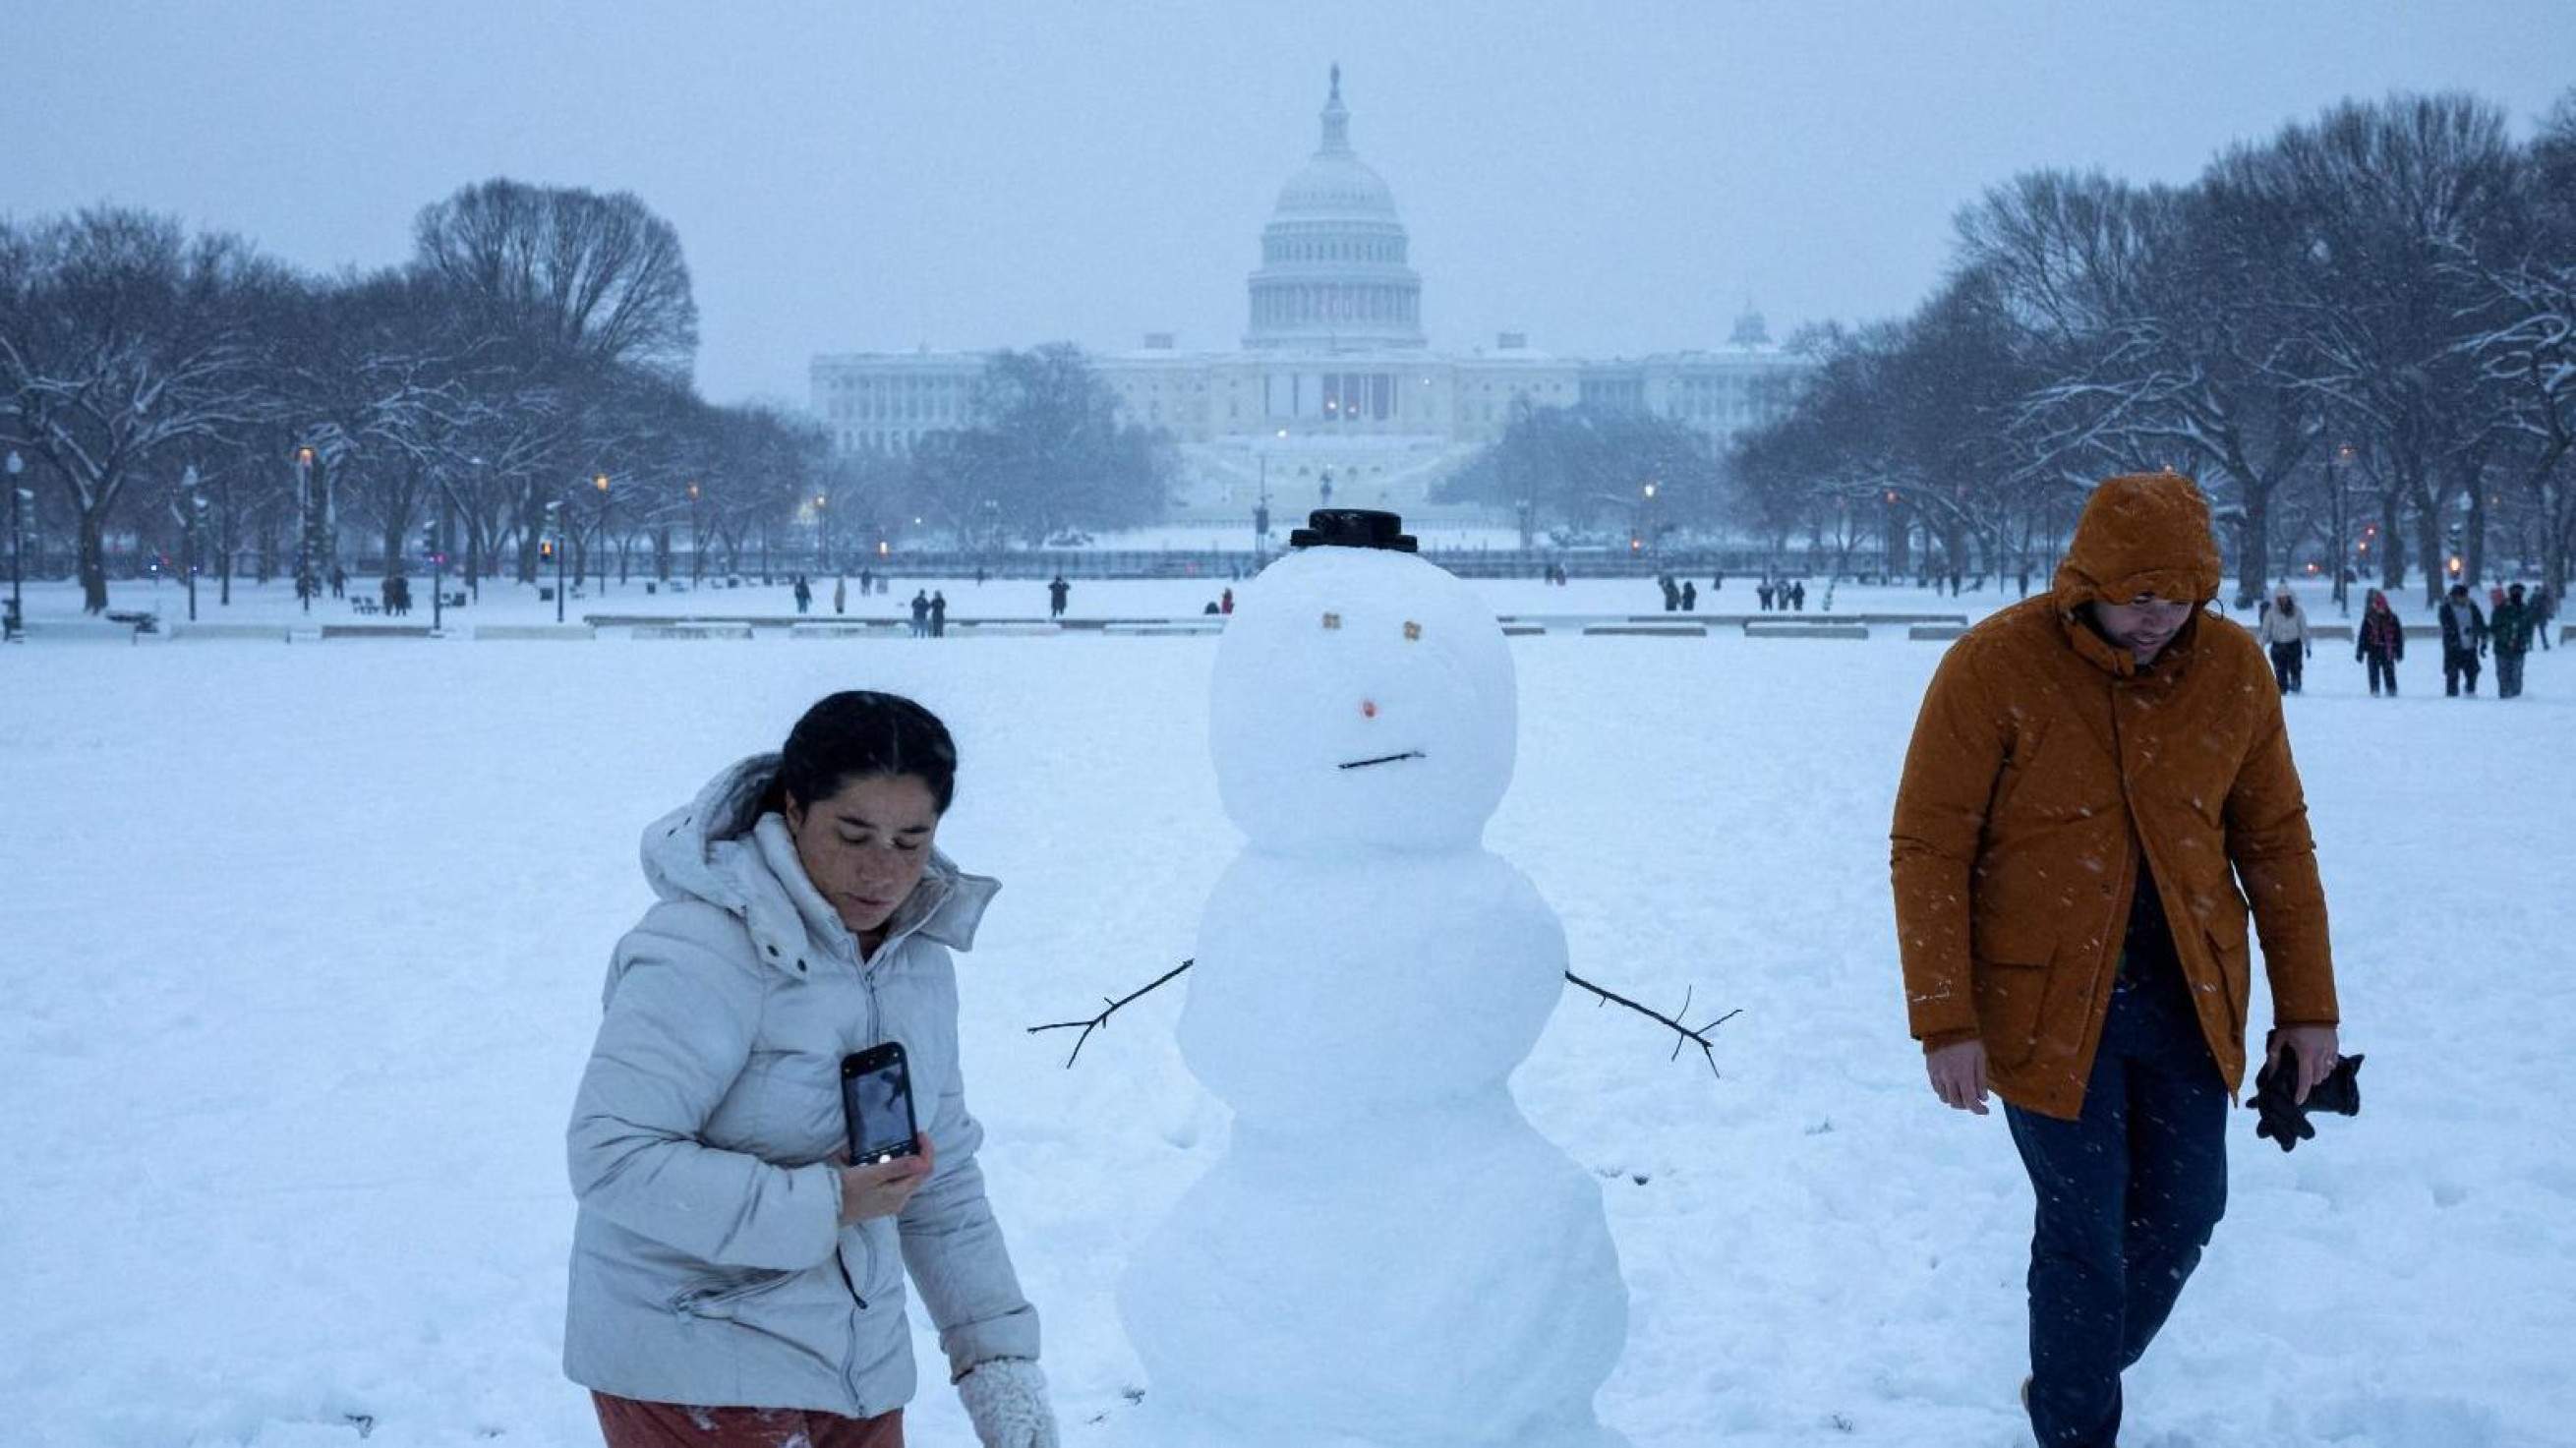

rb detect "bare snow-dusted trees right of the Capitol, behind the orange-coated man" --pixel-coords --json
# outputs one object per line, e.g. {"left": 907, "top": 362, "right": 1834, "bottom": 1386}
{"left": 1728, "top": 90, "right": 2576, "bottom": 601}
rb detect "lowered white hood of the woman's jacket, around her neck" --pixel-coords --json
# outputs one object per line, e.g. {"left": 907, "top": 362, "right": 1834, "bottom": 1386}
{"left": 641, "top": 752, "right": 1002, "bottom": 961}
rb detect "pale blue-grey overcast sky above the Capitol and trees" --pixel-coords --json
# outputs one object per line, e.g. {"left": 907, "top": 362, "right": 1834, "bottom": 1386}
{"left": 0, "top": 0, "right": 2576, "bottom": 402}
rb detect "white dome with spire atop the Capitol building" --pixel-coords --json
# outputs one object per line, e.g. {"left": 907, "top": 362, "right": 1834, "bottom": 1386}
{"left": 1244, "top": 65, "right": 1425, "bottom": 353}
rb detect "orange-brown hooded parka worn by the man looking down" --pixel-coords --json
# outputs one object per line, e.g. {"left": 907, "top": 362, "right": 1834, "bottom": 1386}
{"left": 1891, "top": 474, "right": 2336, "bottom": 1119}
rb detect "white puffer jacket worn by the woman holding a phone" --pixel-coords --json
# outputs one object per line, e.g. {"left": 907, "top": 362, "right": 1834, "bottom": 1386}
{"left": 564, "top": 755, "right": 1038, "bottom": 1418}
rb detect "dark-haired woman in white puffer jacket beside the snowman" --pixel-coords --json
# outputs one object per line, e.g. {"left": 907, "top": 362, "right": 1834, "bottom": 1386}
{"left": 564, "top": 693, "right": 1056, "bottom": 1448}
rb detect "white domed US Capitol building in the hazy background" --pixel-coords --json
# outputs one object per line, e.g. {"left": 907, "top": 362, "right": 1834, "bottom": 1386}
{"left": 811, "top": 67, "right": 1811, "bottom": 528}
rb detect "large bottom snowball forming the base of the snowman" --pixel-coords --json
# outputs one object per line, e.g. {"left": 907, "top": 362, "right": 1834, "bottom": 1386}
{"left": 1118, "top": 1084, "right": 1628, "bottom": 1448}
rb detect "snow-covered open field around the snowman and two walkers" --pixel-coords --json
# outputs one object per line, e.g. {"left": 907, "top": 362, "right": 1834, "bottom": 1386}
{"left": 0, "top": 592, "right": 2576, "bottom": 1448}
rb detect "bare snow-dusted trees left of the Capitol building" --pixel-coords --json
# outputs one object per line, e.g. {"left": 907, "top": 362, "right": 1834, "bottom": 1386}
{"left": 0, "top": 180, "right": 1169, "bottom": 613}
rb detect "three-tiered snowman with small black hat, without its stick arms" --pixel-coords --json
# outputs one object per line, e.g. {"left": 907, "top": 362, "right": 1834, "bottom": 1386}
{"left": 1118, "top": 510, "right": 1628, "bottom": 1448}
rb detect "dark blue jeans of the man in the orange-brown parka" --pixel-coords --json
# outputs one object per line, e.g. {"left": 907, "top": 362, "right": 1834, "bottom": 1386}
{"left": 2004, "top": 974, "right": 2228, "bottom": 1448}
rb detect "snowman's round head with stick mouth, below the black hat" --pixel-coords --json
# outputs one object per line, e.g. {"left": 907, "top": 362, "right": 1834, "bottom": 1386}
{"left": 1208, "top": 536, "right": 1520, "bottom": 850}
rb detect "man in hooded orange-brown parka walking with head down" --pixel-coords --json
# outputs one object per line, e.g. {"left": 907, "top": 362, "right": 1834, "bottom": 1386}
{"left": 1894, "top": 472, "right": 2336, "bottom": 1448}
